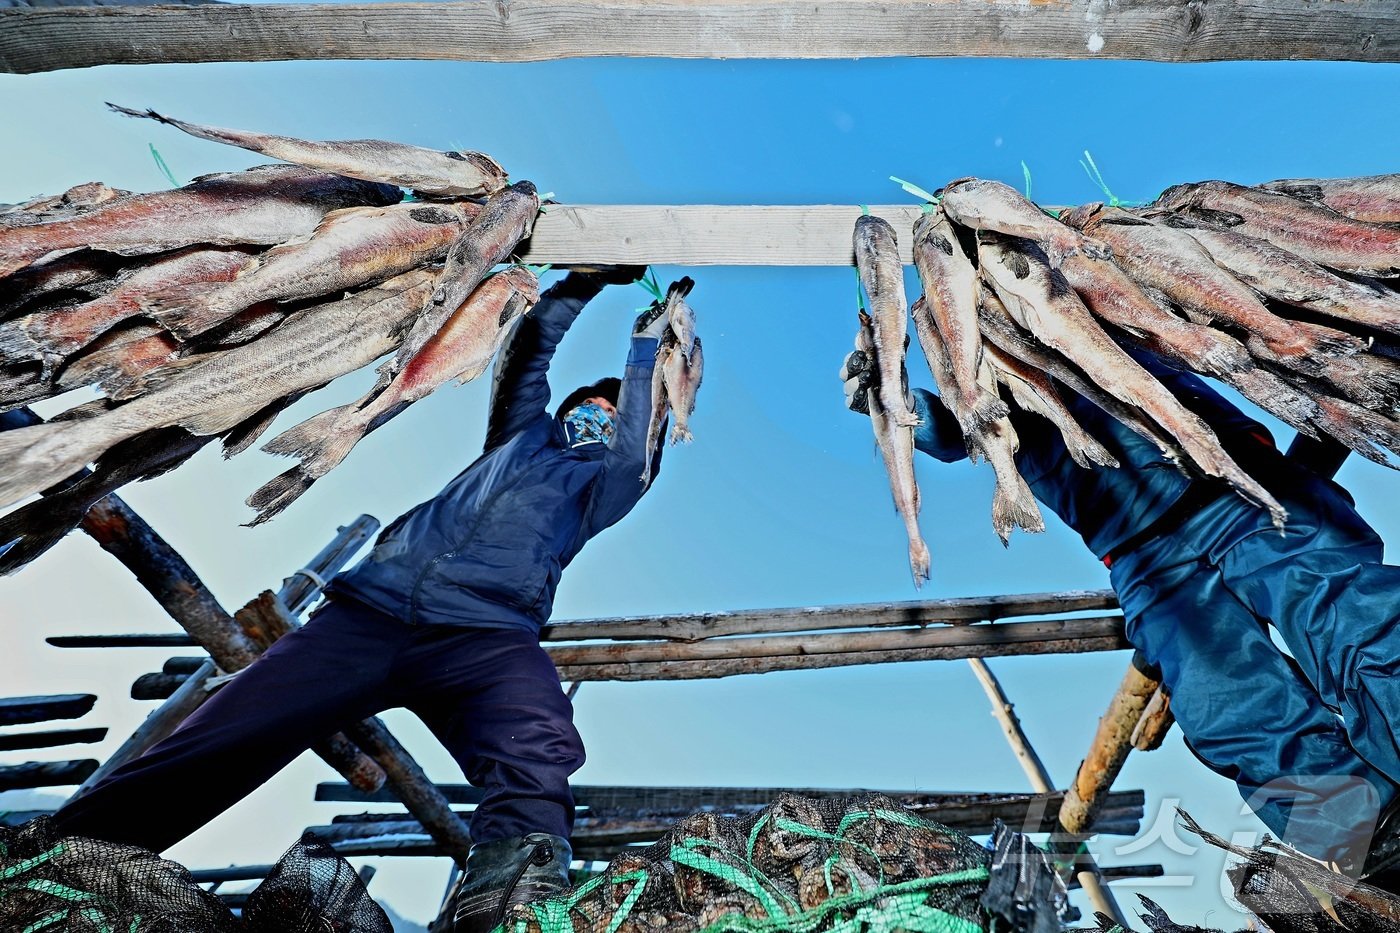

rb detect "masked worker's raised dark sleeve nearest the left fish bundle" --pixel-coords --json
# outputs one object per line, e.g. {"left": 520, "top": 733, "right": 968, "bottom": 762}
{"left": 486, "top": 276, "right": 602, "bottom": 450}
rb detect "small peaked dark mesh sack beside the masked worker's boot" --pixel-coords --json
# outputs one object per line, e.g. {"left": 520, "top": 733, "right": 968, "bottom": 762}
{"left": 242, "top": 832, "right": 393, "bottom": 933}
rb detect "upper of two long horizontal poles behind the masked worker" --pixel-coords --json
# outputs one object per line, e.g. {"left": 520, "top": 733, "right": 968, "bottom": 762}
{"left": 540, "top": 590, "right": 1119, "bottom": 642}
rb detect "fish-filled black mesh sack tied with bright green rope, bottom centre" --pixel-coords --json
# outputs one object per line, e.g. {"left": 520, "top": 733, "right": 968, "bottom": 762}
{"left": 503, "top": 794, "right": 1005, "bottom": 933}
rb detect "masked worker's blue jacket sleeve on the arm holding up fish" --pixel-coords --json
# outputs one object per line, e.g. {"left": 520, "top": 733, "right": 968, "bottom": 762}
{"left": 584, "top": 336, "right": 662, "bottom": 537}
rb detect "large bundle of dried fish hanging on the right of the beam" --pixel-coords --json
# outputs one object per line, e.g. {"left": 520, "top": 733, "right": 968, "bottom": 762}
{"left": 855, "top": 175, "right": 1400, "bottom": 581}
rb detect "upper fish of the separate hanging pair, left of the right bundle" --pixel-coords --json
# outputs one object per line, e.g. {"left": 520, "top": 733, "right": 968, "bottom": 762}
{"left": 854, "top": 214, "right": 918, "bottom": 427}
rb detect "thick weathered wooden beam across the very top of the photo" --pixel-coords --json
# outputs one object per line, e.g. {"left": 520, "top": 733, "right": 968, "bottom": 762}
{"left": 0, "top": 0, "right": 1400, "bottom": 74}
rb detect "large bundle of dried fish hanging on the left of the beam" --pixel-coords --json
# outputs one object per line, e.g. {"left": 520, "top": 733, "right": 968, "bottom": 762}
{"left": 0, "top": 101, "right": 539, "bottom": 570}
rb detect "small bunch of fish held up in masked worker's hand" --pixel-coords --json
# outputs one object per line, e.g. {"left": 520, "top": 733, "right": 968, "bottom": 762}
{"left": 641, "top": 276, "right": 704, "bottom": 483}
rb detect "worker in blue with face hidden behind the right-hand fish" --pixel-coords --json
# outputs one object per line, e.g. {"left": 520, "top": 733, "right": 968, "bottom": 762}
{"left": 841, "top": 353, "right": 1400, "bottom": 874}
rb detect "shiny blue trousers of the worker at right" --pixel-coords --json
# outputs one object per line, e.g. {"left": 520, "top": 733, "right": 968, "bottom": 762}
{"left": 1110, "top": 482, "right": 1400, "bottom": 863}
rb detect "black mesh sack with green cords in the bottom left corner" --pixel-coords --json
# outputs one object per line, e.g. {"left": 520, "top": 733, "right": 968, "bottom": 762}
{"left": 0, "top": 817, "right": 239, "bottom": 933}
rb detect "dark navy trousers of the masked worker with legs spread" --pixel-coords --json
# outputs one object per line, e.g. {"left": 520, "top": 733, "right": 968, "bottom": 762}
{"left": 55, "top": 601, "right": 584, "bottom": 852}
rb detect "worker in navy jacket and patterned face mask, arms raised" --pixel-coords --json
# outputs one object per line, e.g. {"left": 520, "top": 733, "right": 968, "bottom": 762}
{"left": 55, "top": 266, "right": 665, "bottom": 930}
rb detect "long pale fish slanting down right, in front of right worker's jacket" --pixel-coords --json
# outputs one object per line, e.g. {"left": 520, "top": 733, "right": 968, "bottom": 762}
{"left": 977, "top": 233, "right": 1288, "bottom": 530}
